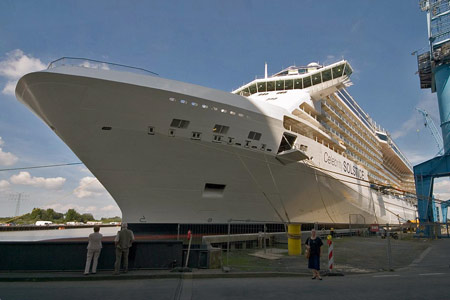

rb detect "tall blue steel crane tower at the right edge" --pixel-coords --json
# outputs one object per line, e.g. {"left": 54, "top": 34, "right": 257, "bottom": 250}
{"left": 414, "top": 0, "right": 450, "bottom": 230}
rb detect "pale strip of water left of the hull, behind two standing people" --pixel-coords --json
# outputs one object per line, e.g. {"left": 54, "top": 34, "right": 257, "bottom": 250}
{"left": 0, "top": 227, "right": 120, "bottom": 242}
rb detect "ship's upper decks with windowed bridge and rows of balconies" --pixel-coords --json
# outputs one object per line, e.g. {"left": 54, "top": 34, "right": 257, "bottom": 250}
{"left": 233, "top": 60, "right": 415, "bottom": 193}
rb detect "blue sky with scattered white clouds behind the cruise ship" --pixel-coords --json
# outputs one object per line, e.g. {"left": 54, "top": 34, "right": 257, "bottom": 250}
{"left": 0, "top": 0, "right": 450, "bottom": 217}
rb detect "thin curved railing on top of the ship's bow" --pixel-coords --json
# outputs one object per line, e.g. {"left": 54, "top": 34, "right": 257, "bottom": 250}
{"left": 47, "top": 57, "right": 159, "bottom": 76}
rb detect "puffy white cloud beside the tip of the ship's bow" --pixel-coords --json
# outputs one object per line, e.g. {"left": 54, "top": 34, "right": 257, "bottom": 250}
{"left": 0, "top": 49, "right": 47, "bottom": 95}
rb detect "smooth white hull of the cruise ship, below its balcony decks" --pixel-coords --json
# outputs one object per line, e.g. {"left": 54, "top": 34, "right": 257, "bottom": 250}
{"left": 16, "top": 64, "right": 416, "bottom": 224}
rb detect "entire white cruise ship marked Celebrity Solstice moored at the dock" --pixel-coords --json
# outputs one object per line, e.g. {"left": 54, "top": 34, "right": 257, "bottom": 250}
{"left": 16, "top": 58, "right": 417, "bottom": 225}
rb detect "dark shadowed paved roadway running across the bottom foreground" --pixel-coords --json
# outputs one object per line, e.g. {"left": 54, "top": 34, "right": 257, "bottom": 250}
{"left": 0, "top": 239, "right": 450, "bottom": 300}
